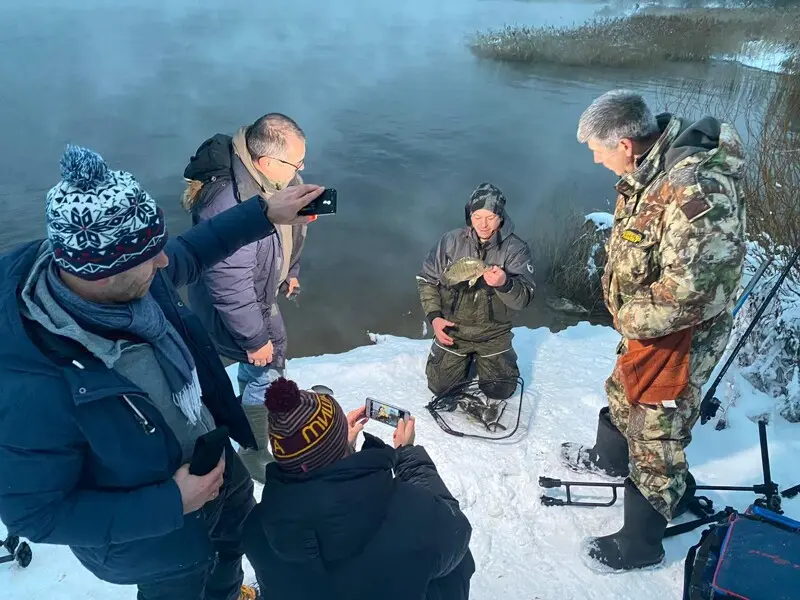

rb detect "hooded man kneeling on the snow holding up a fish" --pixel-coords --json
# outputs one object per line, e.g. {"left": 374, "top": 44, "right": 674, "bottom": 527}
{"left": 417, "top": 183, "right": 535, "bottom": 400}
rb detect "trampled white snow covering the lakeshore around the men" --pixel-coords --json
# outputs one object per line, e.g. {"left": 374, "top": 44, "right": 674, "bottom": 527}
{"left": 0, "top": 323, "right": 800, "bottom": 600}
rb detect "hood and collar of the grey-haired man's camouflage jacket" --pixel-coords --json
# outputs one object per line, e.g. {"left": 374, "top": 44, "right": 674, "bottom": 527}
{"left": 617, "top": 113, "right": 744, "bottom": 196}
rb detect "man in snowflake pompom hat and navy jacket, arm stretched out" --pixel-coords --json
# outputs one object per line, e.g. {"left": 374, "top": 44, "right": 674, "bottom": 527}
{"left": 0, "top": 146, "right": 323, "bottom": 600}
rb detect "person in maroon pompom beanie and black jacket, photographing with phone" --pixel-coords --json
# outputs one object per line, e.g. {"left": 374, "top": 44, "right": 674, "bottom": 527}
{"left": 244, "top": 378, "right": 475, "bottom": 600}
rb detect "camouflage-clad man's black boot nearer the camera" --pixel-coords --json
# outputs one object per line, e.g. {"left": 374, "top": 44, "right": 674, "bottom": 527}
{"left": 588, "top": 479, "right": 667, "bottom": 571}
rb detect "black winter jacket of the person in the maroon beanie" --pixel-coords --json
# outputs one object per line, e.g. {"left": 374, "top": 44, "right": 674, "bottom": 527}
{"left": 244, "top": 434, "right": 475, "bottom": 600}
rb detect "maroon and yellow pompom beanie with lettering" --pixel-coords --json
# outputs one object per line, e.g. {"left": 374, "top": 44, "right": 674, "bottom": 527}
{"left": 264, "top": 377, "right": 347, "bottom": 473}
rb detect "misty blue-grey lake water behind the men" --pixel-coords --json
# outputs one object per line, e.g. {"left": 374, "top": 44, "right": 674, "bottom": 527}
{"left": 0, "top": 0, "right": 736, "bottom": 356}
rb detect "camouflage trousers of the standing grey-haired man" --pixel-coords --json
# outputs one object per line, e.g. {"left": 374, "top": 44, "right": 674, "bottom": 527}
{"left": 606, "top": 369, "right": 700, "bottom": 520}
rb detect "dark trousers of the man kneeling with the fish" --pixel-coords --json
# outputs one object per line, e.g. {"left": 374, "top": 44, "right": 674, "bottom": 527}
{"left": 425, "top": 332, "right": 519, "bottom": 400}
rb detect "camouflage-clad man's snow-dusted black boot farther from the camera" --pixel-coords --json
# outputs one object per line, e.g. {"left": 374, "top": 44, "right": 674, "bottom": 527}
{"left": 561, "top": 406, "right": 630, "bottom": 477}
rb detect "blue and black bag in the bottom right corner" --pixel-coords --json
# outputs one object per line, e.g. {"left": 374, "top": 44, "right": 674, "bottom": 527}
{"left": 683, "top": 506, "right": 800, "bottom": 600}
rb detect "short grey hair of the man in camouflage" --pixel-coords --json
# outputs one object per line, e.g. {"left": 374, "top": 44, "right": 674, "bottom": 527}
{"left": 578, "top": 90, "right": 659, "bottom": 148}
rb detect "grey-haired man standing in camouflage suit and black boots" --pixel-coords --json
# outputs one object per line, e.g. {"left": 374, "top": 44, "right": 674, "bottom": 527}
{"left": 562, "top": 90, "right": 745, "bottom": 570}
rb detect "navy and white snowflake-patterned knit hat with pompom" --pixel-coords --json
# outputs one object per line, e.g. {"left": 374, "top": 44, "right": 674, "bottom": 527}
{"left": 46, "top": 145, "right": 167, "bottom": 281}
